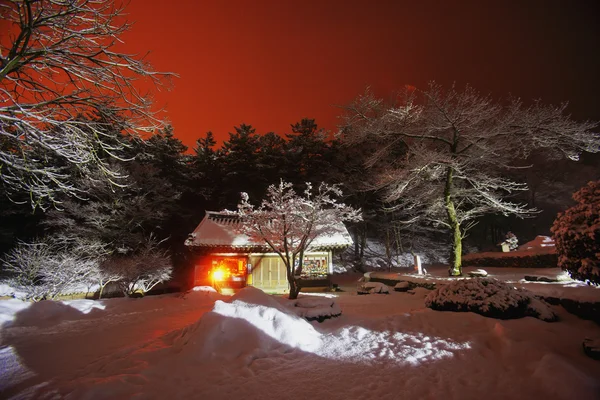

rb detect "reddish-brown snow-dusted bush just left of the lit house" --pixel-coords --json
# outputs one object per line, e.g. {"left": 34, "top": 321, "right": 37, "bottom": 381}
{"left": 101, "top": 238, "right": 173, "bottom": 296}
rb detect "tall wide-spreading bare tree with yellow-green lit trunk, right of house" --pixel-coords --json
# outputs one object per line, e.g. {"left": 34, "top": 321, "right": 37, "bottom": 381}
{"left": 342, "top": 83, "right": 600, "bottom": 275}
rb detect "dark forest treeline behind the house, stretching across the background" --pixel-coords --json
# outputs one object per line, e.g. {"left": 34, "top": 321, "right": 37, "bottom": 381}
{"left": 0, "top": 115, "right": 598, "bottom": 278}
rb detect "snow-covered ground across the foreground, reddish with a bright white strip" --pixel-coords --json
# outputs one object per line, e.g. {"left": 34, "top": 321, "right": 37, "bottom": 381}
{"left": 0, "top": 271, "right": 600, "bottom": 400}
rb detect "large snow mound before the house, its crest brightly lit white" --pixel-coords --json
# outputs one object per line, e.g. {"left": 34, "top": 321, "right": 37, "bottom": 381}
{"left": 167, "top": 287, "right": 321, "bottom": 364}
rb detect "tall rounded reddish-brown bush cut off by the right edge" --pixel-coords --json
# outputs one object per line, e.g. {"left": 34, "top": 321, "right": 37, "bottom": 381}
{"left": 552, "top": 181, "right": 600, "bottom": 285}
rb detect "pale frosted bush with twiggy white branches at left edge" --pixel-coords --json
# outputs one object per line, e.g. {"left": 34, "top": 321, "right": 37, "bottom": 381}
{"left": 2, "top": 238, "right": 106, "bottom": 301}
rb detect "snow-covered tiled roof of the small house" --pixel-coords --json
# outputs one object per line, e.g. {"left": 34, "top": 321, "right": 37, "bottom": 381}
{"left": 185, "top": 211, "right": 354, "bottom": 249}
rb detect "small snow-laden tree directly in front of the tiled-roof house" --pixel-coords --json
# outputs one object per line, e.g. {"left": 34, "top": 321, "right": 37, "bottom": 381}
{"left": 237, "top": 181, "right": 361, "bottom": 299}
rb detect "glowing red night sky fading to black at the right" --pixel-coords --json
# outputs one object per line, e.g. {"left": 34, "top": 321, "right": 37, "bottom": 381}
{"left": 115, "top": 0, "right": 600, "bottom": 147}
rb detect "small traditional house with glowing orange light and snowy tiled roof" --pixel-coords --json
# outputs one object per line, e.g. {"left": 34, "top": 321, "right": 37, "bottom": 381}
{"left": 185, "top": 211, "right": 353, "bottom": 292}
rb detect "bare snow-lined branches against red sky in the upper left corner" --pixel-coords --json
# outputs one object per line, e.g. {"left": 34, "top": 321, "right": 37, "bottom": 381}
{"left": 0, "top": 0, "right": 171, "bottom": 207}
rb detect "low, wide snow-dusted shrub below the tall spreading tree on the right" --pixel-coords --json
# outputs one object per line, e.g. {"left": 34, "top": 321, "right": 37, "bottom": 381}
{"left": 425, "top": 278, "right": 557, "bottom": 322}
